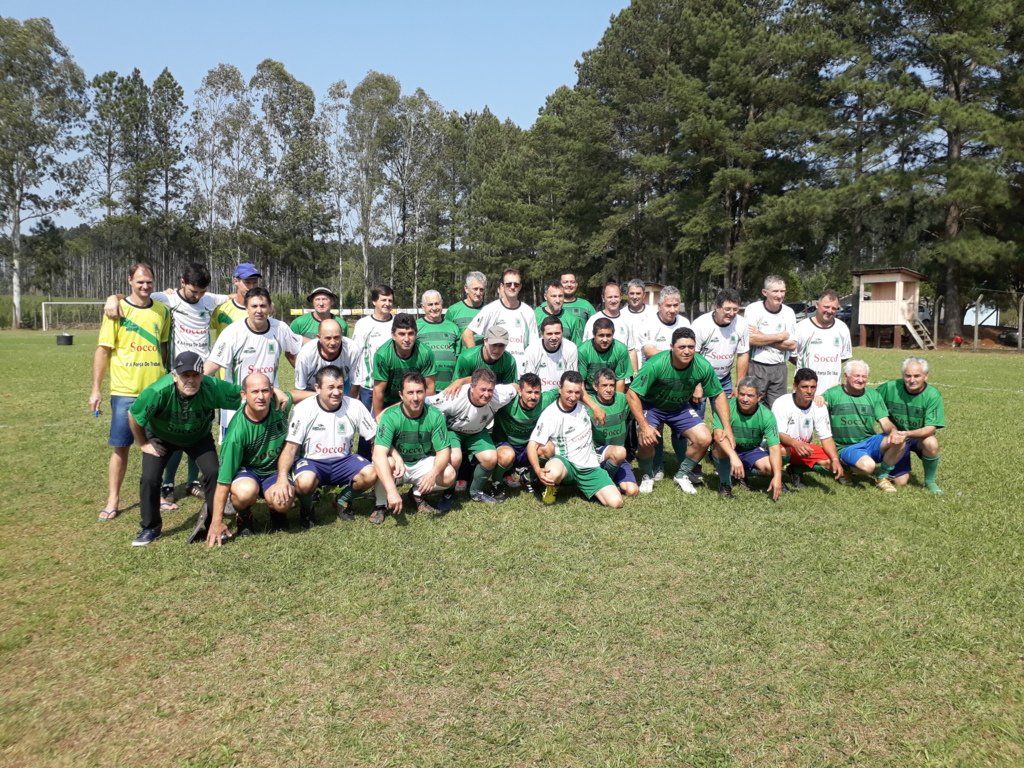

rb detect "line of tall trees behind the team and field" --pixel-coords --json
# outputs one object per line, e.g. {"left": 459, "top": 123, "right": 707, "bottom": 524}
{"left": 0, "top": 0, "right": 1024, "bottom": 336}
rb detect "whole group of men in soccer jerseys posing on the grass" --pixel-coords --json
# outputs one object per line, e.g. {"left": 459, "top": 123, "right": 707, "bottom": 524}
{"left": 90, "top": 264, "right": 944, "bottom": 546}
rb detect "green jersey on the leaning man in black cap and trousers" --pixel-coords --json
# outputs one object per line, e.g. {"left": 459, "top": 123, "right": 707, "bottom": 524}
{"left": 129, "top": 374, "right": 242, "bottom": 447}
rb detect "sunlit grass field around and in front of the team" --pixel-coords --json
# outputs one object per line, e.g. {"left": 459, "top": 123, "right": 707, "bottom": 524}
{"left": 0, "top": 332, "right": 1024, "bottom": 768}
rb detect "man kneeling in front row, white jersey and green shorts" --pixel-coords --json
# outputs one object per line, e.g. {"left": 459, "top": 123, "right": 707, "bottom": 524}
{"left": 526, "top": 371, "right": 623, "bottom": 509}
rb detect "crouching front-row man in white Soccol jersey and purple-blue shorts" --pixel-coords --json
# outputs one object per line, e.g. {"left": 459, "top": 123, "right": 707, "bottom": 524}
{"left": 270, "top": 366, "right": 384, "bottom": 530}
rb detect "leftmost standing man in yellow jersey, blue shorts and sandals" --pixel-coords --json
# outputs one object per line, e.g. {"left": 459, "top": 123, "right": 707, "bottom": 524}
{"left": 89, "top": 263, "right": 171, "bottom": 520}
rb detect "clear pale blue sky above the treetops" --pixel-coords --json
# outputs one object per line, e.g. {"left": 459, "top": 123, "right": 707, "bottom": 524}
{"left": 8, "top": 0, "right": 628, "bottom": 128}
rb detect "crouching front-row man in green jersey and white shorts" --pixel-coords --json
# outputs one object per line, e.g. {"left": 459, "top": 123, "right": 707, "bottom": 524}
{"left": 374, "top": 370, "right": 455, "bottom": 515}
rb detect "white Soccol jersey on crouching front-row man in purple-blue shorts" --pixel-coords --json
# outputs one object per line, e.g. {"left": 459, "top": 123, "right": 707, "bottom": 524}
{"left": 287, "top": 397, "right": 377, "bottom": 460}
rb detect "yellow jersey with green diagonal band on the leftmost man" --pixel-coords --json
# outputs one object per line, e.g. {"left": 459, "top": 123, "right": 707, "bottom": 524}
{"left": 99, "top": 299, "right": 171, "bottom": 397}
